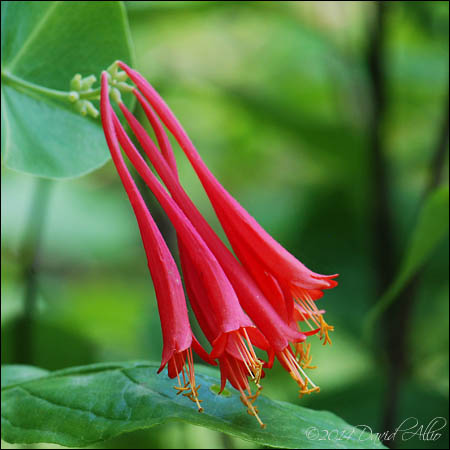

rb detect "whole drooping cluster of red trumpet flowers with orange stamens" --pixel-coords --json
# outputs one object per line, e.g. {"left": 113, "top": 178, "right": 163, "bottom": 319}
{"left": 99, "top": 62, "right": 337, "bottom": 427}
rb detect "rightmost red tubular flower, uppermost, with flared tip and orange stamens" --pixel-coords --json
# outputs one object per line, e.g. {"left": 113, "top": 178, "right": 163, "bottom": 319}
{"left": 119, "top": 62, "right": 337, "bottom": 344}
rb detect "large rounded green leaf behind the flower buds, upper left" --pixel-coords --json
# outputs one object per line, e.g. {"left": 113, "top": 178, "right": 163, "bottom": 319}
{"left": 1, "top": 1, "right": 132, "bottom": 178}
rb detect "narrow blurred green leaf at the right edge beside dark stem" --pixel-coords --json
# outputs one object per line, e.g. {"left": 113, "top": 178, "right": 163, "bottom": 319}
{"left": 365, "top": 186, "right": 449, "bottom": 337}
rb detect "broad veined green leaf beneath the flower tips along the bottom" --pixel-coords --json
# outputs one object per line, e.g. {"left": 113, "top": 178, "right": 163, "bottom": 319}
{"left": 2, "top": 362, "right": 384, "bottom": 448}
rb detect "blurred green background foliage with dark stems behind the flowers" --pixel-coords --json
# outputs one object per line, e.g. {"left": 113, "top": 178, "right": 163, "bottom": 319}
{"left": 1, "top": 1, "right": 449, "bottom": 448}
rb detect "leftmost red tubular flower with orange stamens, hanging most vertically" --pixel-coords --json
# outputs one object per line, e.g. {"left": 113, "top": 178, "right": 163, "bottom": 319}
{"left": 101, "top": 74, "right": 212, "bottom": 411}
